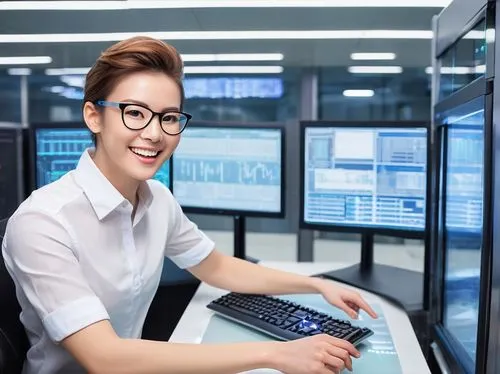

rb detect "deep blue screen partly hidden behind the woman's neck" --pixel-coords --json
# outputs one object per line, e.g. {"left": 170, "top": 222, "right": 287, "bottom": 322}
{"left": 36, "top": 128, "right": 169, "bottom": 188}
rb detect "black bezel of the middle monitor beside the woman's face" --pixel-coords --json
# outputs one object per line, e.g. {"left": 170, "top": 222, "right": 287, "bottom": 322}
{"left": 172, "top": 121, "right": 286, "bottom": 218}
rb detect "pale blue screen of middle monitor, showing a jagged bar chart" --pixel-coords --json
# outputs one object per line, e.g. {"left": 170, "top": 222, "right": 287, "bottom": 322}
{"left": 173, "top": 126, "right": 283, "bottom": 214}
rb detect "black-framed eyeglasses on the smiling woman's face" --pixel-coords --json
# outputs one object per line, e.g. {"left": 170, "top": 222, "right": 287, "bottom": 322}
{"left": 95, "top": 100, "right": 192, "bottom": 135}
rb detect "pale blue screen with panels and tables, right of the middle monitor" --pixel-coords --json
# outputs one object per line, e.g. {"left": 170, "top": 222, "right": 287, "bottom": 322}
{"left": 304, "top": 127, "right": 427, "bottom": 231}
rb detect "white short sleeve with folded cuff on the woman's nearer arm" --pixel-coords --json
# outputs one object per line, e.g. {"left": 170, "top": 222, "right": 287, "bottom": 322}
{"left": 2, "top": 212, "right": 109, "bottom": 343}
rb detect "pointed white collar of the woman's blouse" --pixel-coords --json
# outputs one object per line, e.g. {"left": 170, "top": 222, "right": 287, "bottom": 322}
{"left": 75, "top": 148, "right": 153, "bottom": 222}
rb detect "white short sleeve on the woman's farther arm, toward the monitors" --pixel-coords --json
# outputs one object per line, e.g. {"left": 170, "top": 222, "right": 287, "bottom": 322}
{"left": 165, "top": 199, "right": 215, "bottom": 269}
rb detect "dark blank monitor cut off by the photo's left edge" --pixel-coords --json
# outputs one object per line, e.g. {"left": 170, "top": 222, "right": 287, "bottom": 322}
{"left": 0, "top": 123, "right": 24, "bottom": 221}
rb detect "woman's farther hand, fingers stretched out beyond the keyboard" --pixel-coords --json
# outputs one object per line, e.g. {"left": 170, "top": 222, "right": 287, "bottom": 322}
{"left": 319, "top": 279, "right": 378, "bottom": 319}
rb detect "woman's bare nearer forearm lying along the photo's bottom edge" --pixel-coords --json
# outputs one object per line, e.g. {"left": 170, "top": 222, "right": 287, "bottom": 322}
{"left": 94, "top": 339, "right": 280, "bottom": 374}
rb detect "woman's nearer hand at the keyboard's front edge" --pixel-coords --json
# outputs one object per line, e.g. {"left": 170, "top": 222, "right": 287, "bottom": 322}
{"left": 273, "top": 334, "right": 360, "bottom": 374}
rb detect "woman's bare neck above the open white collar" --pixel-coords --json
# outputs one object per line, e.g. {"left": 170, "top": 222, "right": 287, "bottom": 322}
{"left": 90, "top": 150, "right": 140, "bottom": 206}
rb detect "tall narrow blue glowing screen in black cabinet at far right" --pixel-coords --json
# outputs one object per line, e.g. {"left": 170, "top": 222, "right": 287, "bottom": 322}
{"left": 439, "top": 97, "right": 485, "bottom": 369}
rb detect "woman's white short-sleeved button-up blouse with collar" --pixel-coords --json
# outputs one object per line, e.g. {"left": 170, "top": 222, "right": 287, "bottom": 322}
{"left": 2, "top": 150, "right": 214, "bottom": 374}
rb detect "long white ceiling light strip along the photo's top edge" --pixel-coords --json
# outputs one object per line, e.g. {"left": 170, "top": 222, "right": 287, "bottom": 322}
{"left": 0, "top": 0, "right": 451, "bottom": 10}
